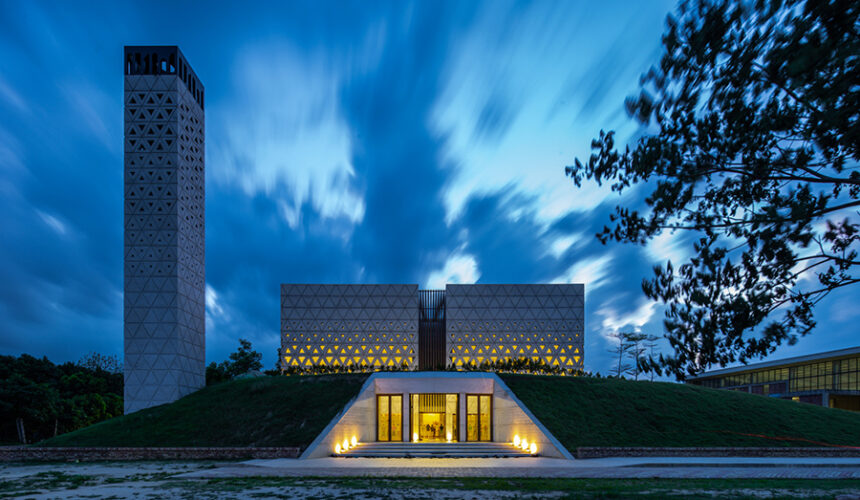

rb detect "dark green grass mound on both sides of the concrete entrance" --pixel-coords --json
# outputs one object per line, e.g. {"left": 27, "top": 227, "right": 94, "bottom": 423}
{"left": 39, "top": 374, "right": 860, "bottom": 451}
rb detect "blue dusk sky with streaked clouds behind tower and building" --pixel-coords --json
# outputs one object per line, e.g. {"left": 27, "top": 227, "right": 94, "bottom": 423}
{"left": 0, "top": 0, "right": 860, "bottom": 373}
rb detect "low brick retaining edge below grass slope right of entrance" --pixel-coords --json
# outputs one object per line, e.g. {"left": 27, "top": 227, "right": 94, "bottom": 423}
{"left": 573, "top": 446, "right": 860, "bottom": 458}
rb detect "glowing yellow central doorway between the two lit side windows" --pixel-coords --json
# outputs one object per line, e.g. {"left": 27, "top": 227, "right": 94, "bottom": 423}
{"left": 409, "top": 394, "right": 460, "bottom": 442}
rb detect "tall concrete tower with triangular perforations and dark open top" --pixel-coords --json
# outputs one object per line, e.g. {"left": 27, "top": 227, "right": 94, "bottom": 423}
{"left": 123, "top": 46, "right": 206, "bottom": 413}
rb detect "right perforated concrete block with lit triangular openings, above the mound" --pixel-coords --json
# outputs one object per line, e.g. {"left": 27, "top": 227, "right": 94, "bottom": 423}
{"left": 445, "top": 284, "right": 585, "bottom": 370}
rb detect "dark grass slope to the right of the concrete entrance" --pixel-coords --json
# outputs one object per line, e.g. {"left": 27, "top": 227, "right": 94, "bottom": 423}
{"left": 501, "top": 374, "right": 860, "bottom": 451}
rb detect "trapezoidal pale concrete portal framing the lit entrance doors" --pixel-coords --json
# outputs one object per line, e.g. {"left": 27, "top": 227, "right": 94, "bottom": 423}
{"left": 302, "top": 372, "right": 572, "bottom": 458}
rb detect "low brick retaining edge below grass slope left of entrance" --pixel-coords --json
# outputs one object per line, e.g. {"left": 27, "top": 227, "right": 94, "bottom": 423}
{"left": 0, "top": 446, "right": 301, "bottom": 462}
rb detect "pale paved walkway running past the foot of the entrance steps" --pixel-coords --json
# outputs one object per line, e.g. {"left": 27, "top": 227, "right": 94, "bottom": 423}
{"left": 177, "top": 457, "right": 860, "bottom": 479}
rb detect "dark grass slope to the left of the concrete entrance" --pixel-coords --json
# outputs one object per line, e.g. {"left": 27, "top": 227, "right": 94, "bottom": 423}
{"left": 39, "top": 375, "right": 367, "bottom": 447}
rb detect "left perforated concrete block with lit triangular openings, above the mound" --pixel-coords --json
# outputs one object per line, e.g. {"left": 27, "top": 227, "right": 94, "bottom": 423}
{"left": 281, "top": 284, "right": 418, "bottom": 369}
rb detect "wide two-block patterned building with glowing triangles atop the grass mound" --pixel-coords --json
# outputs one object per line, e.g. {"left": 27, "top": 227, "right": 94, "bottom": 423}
{"left": 280, "top": 284, "right": 585, "bottom": 371}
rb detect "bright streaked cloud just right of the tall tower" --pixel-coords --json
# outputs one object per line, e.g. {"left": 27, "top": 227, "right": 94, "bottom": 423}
{"left": 214, "top": 43, "right": 365, "bottom": 229}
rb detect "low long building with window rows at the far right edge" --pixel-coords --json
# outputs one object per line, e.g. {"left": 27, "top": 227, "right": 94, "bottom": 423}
{"left": 687, "top": 347, "right": 860, "bottom": 411}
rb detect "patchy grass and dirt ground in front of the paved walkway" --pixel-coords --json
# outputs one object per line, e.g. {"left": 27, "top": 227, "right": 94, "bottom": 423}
{"left": 0, "top": 459, "right": 860, "bottom": 500}
